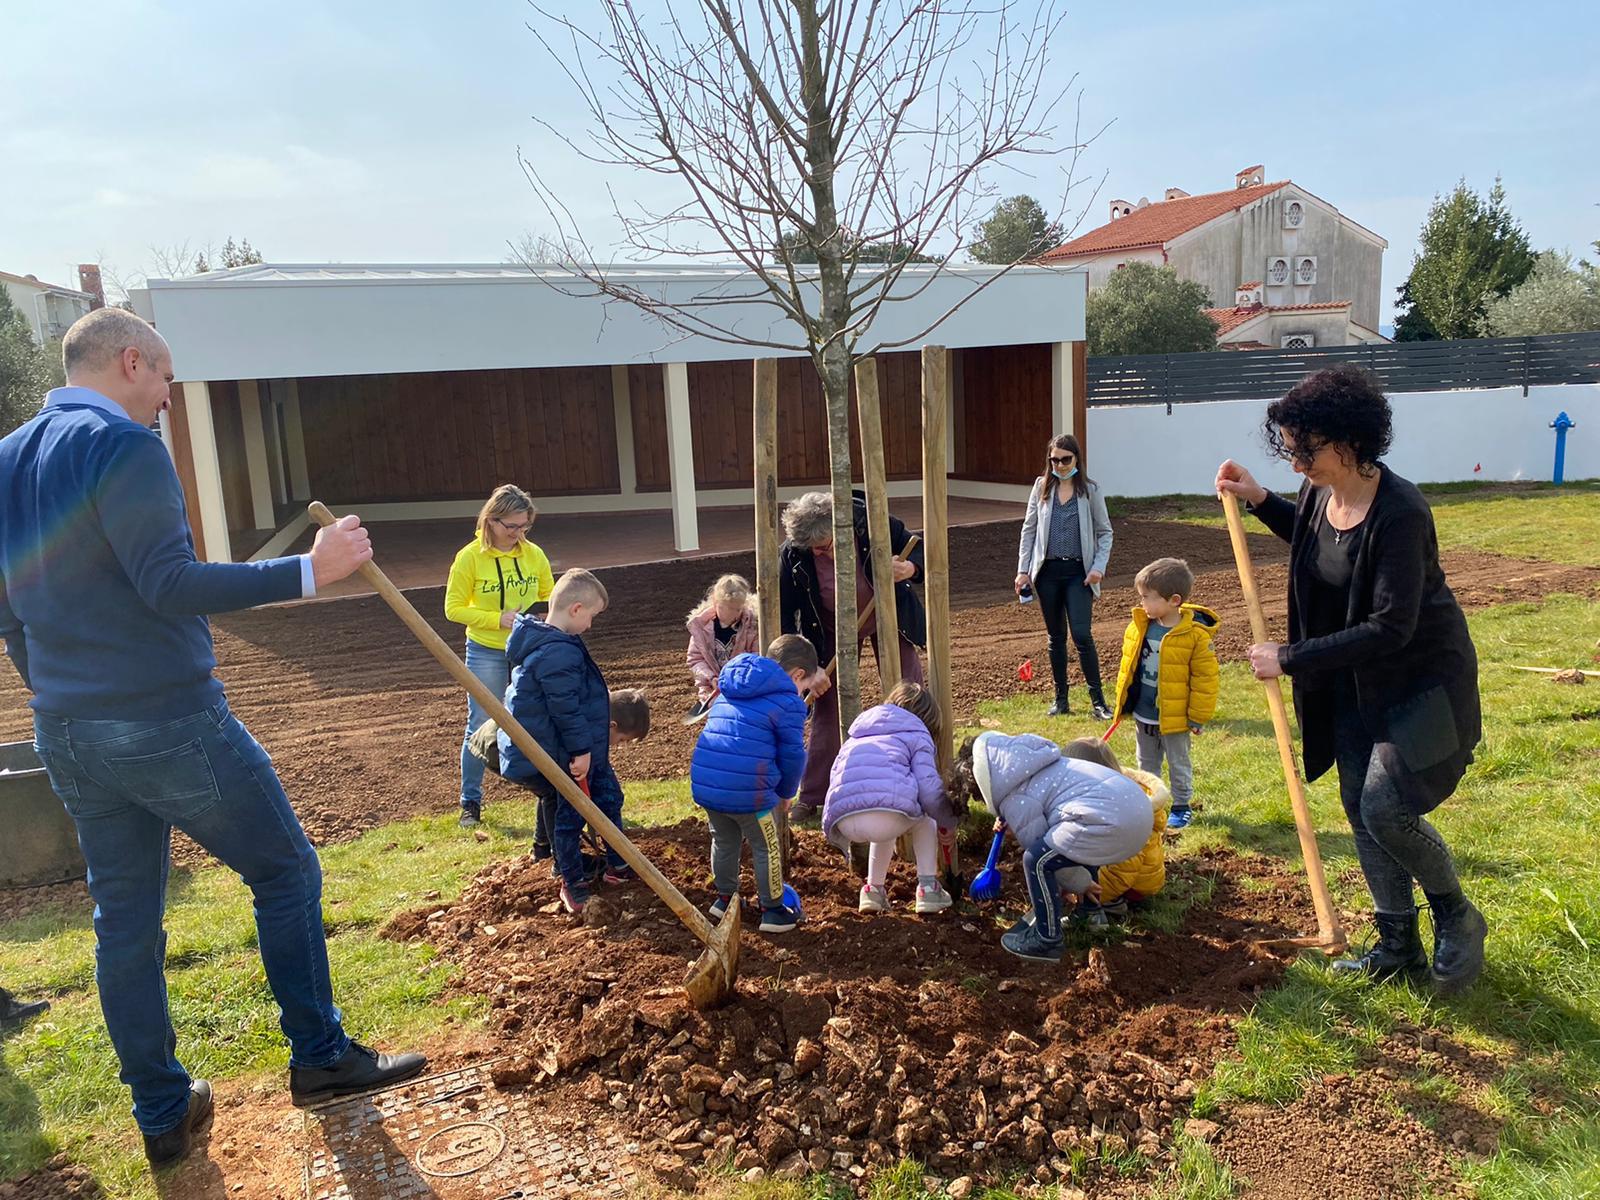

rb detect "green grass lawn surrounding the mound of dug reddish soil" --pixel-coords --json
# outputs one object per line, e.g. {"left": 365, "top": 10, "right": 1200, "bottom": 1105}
{"left": 0, "top": 485, "right": 1600, "bottom": 1200}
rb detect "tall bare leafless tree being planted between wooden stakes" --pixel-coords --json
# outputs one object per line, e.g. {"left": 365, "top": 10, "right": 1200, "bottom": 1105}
{"left": 523, "top": 0, "right": 1085, "bottom": 726}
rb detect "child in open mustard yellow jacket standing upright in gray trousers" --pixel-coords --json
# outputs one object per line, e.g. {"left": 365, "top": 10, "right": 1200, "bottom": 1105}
{"left": 1114, "top": 558, "right": 1221, "bottom": 829}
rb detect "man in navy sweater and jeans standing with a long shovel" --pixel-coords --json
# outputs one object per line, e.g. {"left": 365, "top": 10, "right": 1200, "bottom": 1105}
{"left": 0, "top": 309, "right": 426, "bottom": 1166}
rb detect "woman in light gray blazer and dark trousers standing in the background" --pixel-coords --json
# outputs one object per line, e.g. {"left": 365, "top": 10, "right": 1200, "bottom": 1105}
{"left": 1016, "top": 434, "right": 1112, "bottom": 722}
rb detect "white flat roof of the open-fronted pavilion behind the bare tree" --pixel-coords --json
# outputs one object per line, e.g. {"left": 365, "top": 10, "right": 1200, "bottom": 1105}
{"left": 131, "top": 262, "right": 1088, "bottom": 379}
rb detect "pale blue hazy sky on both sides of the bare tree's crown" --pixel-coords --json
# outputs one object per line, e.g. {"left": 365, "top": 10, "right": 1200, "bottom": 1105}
{"left": 0, "top": 0, "right": 1600, "bottom": 322}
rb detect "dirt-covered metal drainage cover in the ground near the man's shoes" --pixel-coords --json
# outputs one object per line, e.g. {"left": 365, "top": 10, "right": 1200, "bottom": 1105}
{"left": 306, "top": 1062, "right": 640, "bottom": 1200}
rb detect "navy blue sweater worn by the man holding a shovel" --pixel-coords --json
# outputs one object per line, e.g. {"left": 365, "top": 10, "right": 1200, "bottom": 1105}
{"left": 0, "top": 387, "right": 304, "bottom": 720}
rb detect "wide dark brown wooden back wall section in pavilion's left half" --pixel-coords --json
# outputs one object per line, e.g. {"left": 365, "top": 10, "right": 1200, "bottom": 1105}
{"left": 297, "top": 366, "right": 620, "bottom": 507}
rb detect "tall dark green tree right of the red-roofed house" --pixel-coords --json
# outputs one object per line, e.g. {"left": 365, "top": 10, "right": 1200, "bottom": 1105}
{"left": 1395, "top": 178, "right": 1534, "bottom": 342}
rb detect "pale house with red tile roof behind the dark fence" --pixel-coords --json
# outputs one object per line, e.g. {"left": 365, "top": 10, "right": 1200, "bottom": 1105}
{"left": 1043, "top": 163, "right": 1389, "bottom": 346}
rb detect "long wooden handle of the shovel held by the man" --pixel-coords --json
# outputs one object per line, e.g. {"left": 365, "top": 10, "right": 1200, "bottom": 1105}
{"left": 307, "top": 501, "right": 712, "bottom": 942}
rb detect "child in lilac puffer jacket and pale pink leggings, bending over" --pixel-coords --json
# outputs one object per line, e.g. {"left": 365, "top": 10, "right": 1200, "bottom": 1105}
{"left": 822, "top": 683, "right": 958, "bottom": 912}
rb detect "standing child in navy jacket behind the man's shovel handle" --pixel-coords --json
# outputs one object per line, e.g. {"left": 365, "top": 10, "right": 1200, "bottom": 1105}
{"left": 496, "top": 570, "right": 646, "bottom": 914}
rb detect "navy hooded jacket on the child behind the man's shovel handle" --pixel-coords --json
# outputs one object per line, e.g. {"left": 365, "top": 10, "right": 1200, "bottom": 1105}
{"left": 496, "top": 616, "right": 611, "bottom": 792}
